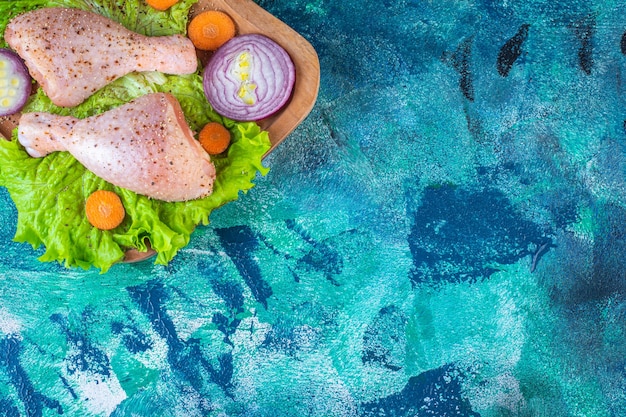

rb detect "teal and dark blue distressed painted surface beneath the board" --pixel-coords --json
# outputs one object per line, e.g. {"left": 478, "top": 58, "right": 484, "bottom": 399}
{"left": 0, "top": 0, "right": 626, "bottom": 417}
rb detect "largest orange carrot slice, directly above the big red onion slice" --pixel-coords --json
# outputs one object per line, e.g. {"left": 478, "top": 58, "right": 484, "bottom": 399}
{"left": 187, "top": 10, "right": 236, "bottom": 51}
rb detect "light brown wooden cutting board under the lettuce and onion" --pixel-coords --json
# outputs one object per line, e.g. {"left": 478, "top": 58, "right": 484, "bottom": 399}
{"left": 0, "top": 0, "right": 320, "bottom": 262}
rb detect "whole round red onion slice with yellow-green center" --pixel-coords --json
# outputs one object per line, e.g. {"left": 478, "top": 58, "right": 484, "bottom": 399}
{"left": 203, "top": 34, "right": 296, "bottom": 121}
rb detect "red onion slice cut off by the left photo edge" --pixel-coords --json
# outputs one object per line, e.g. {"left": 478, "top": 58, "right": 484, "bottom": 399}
{"left": 0, "top": 48, "right": 32, "bottom": 117}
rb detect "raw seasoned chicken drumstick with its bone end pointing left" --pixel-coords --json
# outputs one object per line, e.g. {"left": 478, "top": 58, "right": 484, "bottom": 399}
{"left": 18, "top": 93, "right": 215, "bottom": 201}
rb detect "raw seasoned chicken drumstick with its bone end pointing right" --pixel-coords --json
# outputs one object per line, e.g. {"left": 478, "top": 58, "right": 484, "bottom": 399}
{"left": 4, "top": 7, "right": 198, "bottom": 107}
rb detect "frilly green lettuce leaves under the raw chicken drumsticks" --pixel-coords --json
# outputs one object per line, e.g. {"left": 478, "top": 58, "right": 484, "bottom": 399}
{"left": 0, "top": 0, "right": 271, "bottom": 273}
